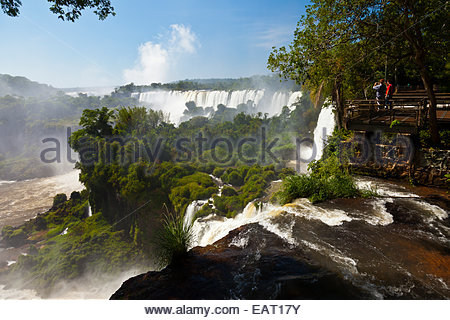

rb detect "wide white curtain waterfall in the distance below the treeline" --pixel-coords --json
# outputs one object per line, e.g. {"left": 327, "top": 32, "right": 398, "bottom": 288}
{"left": 132, "top": 90, "right": 301, "bottom": 123}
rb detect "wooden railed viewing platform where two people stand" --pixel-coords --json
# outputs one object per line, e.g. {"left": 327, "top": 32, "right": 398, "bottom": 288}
{"left": 344, "top": 90, "right": 450, "bottom": 134}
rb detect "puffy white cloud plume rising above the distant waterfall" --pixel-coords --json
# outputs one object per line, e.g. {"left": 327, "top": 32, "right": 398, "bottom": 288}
{"left": 124, "top": 24, "right": 200, "bottom": 84}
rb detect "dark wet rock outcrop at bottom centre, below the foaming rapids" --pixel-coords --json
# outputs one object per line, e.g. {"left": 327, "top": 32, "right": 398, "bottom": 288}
{"left": 111, "top": 224, "right": 366, "bottom": 300}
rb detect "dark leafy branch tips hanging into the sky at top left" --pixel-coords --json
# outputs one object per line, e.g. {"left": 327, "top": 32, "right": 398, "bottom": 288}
{"left": 0, "top": 0, "right": 116, "bottom": 22}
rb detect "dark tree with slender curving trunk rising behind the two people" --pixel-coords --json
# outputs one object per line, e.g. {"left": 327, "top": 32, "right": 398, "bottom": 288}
{"left": 369, "top": 0, "right": 450, "bottom": 145}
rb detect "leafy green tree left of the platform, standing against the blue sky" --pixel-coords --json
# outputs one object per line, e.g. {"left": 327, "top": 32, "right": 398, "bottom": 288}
{"left": 268, "top": 0, "right": 382, "bottom": 126}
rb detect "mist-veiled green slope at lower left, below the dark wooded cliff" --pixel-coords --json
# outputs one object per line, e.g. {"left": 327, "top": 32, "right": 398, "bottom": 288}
{"left": 2, "top": 191, "right": 144, "bottom": 295}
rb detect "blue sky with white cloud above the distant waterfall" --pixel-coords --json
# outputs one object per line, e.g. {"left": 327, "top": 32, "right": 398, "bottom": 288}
{"left": 0, "top": 0, "right": 307, "bottom": 88}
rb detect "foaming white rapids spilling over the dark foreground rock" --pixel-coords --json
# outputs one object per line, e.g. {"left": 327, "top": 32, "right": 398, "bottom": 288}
{"left": 189, "top": 185, "right": 448, "bottom": 247}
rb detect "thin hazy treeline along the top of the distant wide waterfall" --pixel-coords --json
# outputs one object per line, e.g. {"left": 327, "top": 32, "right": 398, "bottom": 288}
{"left": 113, "top": 75, "right": 300, "bottom": 96}
